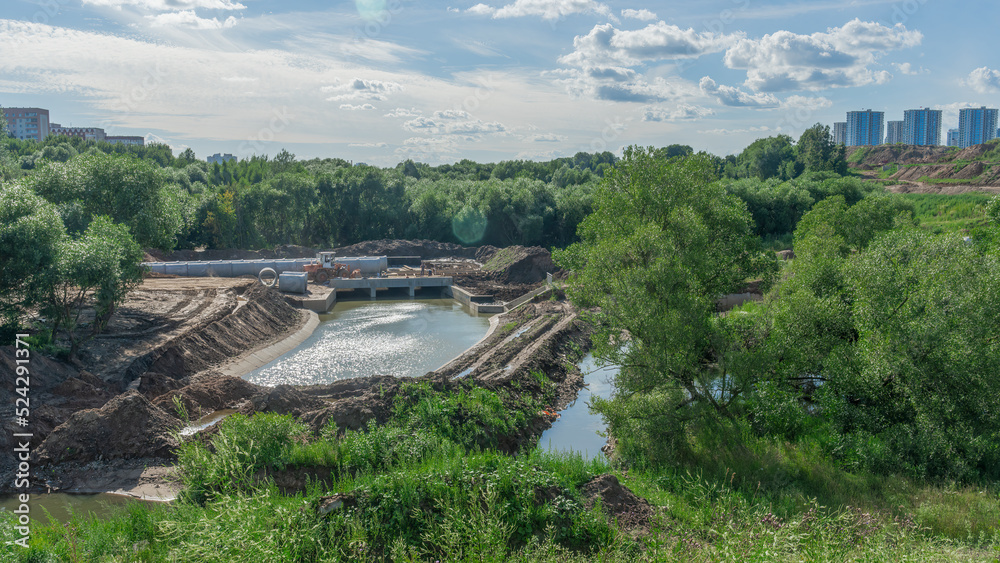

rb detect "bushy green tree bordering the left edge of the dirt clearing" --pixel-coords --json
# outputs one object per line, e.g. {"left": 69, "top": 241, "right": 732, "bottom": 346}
{"left": 44, "top": 216, "right": 143, "bottom": 358}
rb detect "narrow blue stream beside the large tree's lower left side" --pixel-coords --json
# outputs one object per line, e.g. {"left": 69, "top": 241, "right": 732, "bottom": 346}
{"left": 538, "top": 354, "right": 618, "bottom": 460}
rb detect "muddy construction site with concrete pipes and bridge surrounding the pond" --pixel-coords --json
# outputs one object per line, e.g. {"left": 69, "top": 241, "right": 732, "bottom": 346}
{"left": 0, "top": 241, "right": 589, "bottom": 500}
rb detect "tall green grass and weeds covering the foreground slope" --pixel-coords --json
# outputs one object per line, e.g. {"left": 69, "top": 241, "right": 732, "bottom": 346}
{"left": 7, "top": 373, "right": 1000, "bottom": 562}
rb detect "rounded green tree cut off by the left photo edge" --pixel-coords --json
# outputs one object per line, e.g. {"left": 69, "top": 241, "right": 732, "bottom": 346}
{"left": 0, "top": 184, "right": 66, "bottom": 342}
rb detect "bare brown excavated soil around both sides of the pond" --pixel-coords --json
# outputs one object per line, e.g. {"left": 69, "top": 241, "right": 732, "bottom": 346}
{"left": 0, "top": 241, "right": 589, "bottom": 498}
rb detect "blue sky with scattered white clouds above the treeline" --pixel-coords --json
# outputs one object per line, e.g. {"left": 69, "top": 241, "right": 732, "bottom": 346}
{"left": 0, "top": 0, "right": 1000, "bottom": 166}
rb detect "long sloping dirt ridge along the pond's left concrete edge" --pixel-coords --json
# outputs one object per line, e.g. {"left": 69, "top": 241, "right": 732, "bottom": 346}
{"left": 120, "top": 285, "right": 302, "bottom": 387}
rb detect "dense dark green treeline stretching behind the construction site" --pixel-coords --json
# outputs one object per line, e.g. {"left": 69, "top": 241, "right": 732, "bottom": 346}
{"left": 0, "top": 124, "right": 868, "bottom": 251}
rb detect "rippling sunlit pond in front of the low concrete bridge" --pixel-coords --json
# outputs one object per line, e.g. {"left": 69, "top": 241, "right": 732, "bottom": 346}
{"left": 244, "top": 299, "right": 490, "bottom": 386}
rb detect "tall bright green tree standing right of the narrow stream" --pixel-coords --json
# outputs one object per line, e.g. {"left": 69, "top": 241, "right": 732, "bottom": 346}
{"left": 556, "top": 147, "right": 776, "bottom": 460}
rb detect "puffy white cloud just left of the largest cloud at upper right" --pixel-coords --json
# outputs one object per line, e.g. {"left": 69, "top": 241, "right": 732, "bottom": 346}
{"left": 559, "top": 21, "right": 737, "bottom": 68}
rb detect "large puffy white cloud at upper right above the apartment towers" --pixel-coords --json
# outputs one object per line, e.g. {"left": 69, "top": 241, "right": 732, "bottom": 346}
{"left": 724, "top": 19, "right": 923, "bottom": 92}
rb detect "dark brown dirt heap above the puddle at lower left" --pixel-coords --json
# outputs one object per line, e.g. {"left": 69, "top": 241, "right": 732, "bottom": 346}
{"left": 35, "top": 391, "right": 177, "bottom": 465}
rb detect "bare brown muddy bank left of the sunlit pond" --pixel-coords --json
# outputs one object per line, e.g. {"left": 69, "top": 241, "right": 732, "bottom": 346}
{"left": 0, "top": 280, "right": 303, "bottom": 492}
